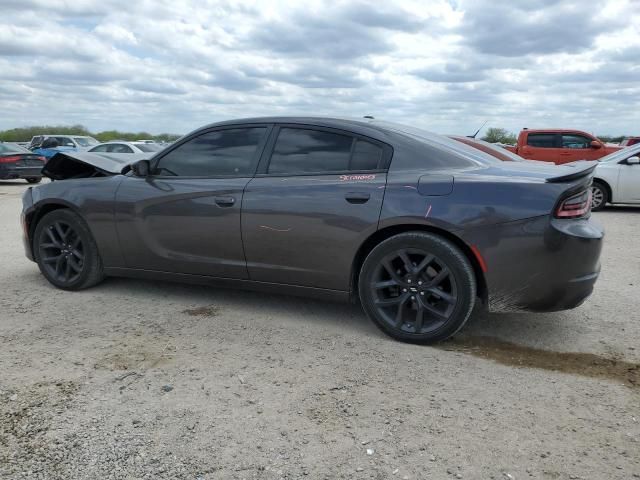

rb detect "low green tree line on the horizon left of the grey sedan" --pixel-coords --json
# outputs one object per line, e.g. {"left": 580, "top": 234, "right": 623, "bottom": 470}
{"left": 0, "top": 125, "right": 180, "bottom": 142}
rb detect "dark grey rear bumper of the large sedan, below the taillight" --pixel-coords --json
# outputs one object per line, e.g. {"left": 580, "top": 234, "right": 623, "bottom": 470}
{"left": 466, "top": 216, "right": 604, "bottom": 312}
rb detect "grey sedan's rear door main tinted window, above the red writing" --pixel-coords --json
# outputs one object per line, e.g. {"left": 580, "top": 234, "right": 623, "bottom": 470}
{"left": 269, "top": 128, "right": 353, "bottom": 174}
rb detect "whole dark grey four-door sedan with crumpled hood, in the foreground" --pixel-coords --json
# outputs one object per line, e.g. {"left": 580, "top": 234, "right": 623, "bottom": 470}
{"left": 17, "top": 117, "right": 603, "bottom": 343}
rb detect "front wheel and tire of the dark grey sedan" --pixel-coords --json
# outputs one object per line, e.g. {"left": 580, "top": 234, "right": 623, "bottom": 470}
{"left": 33, "top": 209, "right": 104, "bottom": 290}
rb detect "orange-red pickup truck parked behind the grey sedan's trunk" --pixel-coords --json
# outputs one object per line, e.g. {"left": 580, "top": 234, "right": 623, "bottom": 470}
{"left": 506, "top": 128, "right": 622, "bottom": 164}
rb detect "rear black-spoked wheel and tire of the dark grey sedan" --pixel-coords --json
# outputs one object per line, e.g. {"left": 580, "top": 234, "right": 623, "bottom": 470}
{"left": 358, "top": 232, "right": 476, "bottom": 344}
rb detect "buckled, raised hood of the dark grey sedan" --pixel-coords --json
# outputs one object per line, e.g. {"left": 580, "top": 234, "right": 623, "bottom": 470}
{"left": 42, "top": 152, "right": 148, "bottom": 180}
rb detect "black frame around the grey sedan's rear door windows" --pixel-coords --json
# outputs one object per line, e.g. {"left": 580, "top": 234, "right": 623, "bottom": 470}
{"left": 255, "top": 123, "right": 393, "bottom": 177}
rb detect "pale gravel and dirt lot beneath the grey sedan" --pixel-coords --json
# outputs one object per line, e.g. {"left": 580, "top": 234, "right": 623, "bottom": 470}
{"left": 0, "top": 182, "right": 640, "bottom": 479}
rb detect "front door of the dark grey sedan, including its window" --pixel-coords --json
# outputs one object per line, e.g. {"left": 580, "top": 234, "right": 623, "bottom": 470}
{"left": 116, "top": 125, "right": 268, "bottom": 279}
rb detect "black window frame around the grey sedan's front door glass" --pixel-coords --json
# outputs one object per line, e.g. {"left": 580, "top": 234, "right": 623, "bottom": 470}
{"left": 150, "top": 123, "right": 273, "bottom": 180}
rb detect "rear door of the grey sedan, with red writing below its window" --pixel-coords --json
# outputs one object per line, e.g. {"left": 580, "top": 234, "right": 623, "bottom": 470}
{"left": 242, "top": 126, "right": 391, "bottom": 291}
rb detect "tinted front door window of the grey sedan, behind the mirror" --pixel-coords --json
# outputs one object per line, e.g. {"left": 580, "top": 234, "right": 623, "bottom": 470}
{"left": 157, "top": 127, "right": 267, "bottom": 177}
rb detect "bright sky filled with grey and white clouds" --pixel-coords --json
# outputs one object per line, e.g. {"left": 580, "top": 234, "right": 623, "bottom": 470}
{"left": 0, "top": 0, "right": 640, "bottom": 134}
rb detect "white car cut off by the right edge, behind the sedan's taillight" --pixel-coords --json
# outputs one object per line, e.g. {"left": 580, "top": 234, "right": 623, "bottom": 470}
{"left": 591, "top": 144, "right": 640, "bottom": 210}
